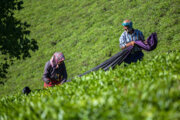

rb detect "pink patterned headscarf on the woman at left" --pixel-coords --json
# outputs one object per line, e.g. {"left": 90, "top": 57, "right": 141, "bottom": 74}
{"left": 50, "top": 52, "right": 65, "bottom": 67}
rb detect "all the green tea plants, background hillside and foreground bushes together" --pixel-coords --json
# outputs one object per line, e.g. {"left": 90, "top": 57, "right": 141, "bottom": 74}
{"left": 0, "top": 0, "right": 180, "bottom": 120}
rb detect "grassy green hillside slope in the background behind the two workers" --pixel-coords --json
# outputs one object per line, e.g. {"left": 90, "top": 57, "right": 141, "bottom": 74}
{"left": 0, "top": 0, "right": 180, "bottom": 96}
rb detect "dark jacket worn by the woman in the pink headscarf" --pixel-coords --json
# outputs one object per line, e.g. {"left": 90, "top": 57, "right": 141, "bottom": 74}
{"left": 42, "top": 61, "right": 67, "bottom": 84}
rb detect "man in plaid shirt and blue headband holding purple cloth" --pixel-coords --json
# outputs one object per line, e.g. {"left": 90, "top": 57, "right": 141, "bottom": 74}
{"left": 119, "top": 20, "right": 144, "bottom": 64}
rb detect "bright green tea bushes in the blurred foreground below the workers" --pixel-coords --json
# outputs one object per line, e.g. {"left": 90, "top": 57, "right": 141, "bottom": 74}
{"left": 0, "top": 51, "right": 180, "bottom": 120}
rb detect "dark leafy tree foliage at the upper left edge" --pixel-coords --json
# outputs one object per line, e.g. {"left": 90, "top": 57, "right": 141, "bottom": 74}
{"left": 0, "top": 0, "right": 38, "bottom": 78}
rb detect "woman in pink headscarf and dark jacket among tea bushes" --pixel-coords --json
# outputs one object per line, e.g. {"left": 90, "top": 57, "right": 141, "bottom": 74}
{"left": 42, "top": 52, "right": 67, "bottom": 88}
